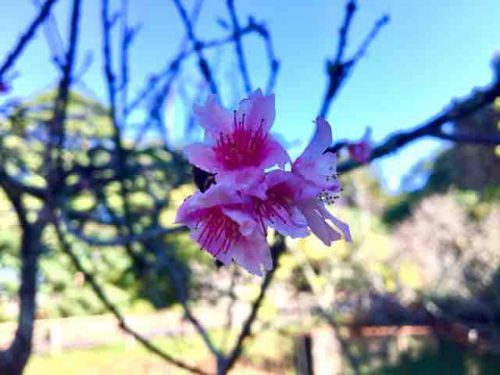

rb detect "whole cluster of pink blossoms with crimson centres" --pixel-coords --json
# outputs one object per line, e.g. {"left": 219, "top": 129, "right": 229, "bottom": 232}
{"left": 176, "top": 90, "right": 351, "bottom": 275}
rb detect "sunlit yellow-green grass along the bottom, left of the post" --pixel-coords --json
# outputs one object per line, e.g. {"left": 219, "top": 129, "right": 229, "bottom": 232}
{"left": 25, "top": 333, "right": 291, "bottom": 375}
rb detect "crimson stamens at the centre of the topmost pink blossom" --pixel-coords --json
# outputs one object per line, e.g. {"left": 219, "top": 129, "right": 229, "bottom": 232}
{"left": 214, "top": 111, "right": 267, "bottom": 170}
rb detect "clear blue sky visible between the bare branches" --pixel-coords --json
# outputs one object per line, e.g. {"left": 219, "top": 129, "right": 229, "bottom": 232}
{"left": 0, "top": 0, "right": 500, "bottom": 190}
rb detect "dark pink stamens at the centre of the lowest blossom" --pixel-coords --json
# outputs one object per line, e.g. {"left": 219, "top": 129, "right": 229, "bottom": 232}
{"left": 196, "top": 207, "right": 241, "bottom": 255}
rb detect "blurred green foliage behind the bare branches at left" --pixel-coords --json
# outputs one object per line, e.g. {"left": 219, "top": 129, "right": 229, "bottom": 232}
{"left": 0, "top": 92, "right": 194, "bottom": 319}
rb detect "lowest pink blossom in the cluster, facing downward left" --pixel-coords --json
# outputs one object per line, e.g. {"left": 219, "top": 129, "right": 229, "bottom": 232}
{"left": 176, "top": 185, "right": 272, "bottom": 275}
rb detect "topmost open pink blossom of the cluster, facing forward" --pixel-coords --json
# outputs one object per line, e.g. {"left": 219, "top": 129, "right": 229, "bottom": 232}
{"left": 185, "top": 90, "right": 290, "bottom": 196}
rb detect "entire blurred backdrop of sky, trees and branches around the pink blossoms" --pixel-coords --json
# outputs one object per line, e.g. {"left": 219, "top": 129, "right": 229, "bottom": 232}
{"left": 0, "top": 0, "right": 500, "bottom": 374}
